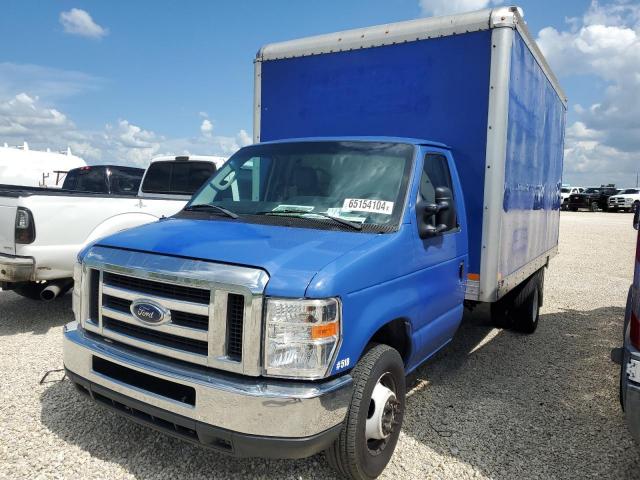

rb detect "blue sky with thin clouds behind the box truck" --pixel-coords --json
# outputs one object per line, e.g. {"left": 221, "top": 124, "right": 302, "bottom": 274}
{"left": 0, "top": 0, "right": 637, "bottom": 186}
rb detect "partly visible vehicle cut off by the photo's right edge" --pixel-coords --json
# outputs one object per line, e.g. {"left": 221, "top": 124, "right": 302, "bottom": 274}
{"left": 611, "top": 206, "right": 640, "bottom": 444}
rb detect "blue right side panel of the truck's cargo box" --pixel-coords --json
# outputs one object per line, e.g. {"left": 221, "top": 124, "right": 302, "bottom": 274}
{"left": 499, "top": 31, "right": 566, "bottom": 288}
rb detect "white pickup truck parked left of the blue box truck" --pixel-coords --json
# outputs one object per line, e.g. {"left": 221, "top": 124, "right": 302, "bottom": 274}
{"left": 0, "top": 156, "right": 225, "bottom": 300}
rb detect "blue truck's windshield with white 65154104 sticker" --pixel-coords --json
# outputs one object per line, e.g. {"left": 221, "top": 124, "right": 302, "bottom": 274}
{"left": 186, "top": 141, "right": 414, "bottom": 231}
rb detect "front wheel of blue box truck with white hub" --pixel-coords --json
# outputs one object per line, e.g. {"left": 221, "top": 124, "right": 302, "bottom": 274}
{"left": 325, "top": 345, "right": 405, "bottom": 480}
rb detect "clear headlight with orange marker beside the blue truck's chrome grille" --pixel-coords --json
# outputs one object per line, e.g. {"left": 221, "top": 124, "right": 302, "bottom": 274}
{"left": 264, "top": 298, "right": 341, "bottom": 379}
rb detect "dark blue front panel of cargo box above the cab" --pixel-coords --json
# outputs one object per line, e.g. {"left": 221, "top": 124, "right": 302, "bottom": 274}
{"left": 259, "top": 30, "right": 491, "bottom": 272}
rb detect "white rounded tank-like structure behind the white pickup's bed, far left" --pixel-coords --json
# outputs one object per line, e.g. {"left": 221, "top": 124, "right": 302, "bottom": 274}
{"left": 0, "top": 142, "right": 87, "bottom": 188}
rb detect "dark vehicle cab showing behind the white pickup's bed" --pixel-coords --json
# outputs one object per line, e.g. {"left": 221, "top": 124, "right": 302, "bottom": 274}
{"left": 62, "top": 165, "right": 144, "bottom": 196}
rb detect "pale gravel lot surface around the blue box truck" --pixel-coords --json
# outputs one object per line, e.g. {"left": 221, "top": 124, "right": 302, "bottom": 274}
{"left": 0, "top": 212, "right": 640, "bottom": 479}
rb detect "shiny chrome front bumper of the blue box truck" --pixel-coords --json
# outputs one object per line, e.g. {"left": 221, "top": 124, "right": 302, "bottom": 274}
{"left": 64, "top": 322, "right": 353, "bottom": 456}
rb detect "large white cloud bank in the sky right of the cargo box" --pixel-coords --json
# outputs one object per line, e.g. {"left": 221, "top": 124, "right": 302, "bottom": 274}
{"left": 537, "top": 1, "right": 640, "bottom": 184}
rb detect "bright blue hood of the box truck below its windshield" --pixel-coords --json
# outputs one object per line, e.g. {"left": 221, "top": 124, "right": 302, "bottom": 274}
{"left": 92, "top": 218, "right": 377, "bottom": 297}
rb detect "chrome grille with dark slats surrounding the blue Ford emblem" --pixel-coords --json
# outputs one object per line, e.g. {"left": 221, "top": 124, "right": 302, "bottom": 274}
{"left": 81, "top": 247, "right": 268, "bottom": 375}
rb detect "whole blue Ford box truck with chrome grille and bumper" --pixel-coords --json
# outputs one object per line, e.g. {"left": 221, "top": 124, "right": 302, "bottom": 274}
{"left": 64, "top": 7, "right": 566, "bottom": 478}
